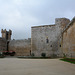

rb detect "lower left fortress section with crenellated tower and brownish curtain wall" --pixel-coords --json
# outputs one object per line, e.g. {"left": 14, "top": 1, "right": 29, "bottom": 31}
{"left": 0, "top": 29, "right": 31, "bottom": 56}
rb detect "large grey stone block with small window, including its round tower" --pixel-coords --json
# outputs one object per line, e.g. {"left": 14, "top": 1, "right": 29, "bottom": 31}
{"left": 31, "top": 18, "right": 70, "bottom": 57}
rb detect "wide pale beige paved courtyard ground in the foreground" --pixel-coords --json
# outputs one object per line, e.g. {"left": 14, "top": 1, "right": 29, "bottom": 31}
{"left": 0, "top": 58, "right": 75, "bottom": 75}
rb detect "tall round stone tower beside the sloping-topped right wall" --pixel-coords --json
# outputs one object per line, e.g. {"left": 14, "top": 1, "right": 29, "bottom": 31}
{"left": 55, "top": 18, "right": 70, "bottom": 57}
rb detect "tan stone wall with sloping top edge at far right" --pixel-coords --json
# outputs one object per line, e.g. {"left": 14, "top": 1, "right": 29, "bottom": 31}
{"left": 63, "top": 18, "right": 75, "bottom": 58}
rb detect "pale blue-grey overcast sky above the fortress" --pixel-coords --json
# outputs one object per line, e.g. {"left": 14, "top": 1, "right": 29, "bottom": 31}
{"left": 0, "top": 0, "right": 75, "bottom": 39}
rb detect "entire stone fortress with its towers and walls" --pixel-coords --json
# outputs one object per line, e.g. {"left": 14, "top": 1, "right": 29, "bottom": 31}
{"left": 0, "top": 17, "right": 75, "bottom": 58}
